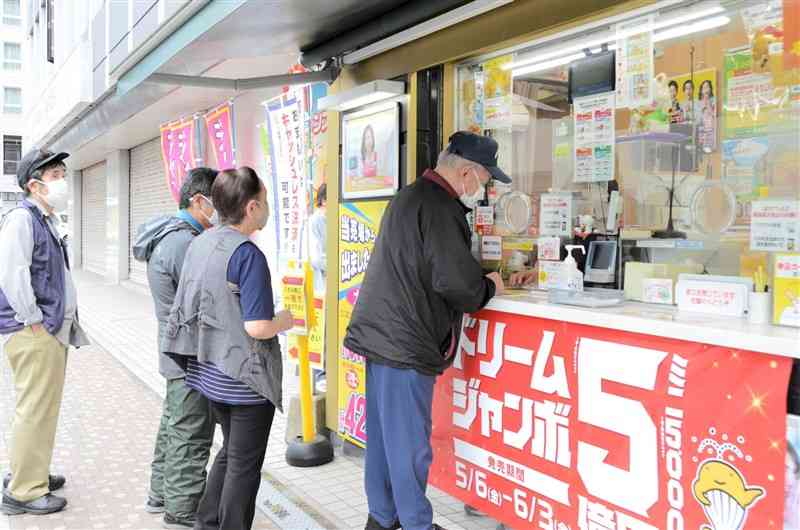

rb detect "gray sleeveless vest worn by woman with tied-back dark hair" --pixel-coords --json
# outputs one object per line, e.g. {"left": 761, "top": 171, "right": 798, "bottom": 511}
{"left": 161, "top": 226, "right": 283, "bottom": 411}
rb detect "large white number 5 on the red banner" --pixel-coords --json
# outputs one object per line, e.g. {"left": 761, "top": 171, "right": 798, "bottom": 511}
{"left": 578, "top": 339, "right": 667, "bottom": 516}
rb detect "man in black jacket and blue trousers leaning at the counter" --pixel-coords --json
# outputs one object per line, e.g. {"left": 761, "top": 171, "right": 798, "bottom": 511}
{"left": 344, "top": 131, "right": 511, "bottom": 530}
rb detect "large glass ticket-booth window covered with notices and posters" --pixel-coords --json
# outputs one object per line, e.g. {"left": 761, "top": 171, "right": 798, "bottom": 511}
{"left": 456, "top": 0, "right": 800, "bottom": 275}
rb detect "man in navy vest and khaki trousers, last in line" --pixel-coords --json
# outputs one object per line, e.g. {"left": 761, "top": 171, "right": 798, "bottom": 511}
{"left": 0, "top": 149, "right": 89, "bottom": 515}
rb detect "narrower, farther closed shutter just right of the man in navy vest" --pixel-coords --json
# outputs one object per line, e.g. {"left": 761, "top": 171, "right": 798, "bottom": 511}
{"left": 81, "top": 162, "right": 107, "bottom": 275}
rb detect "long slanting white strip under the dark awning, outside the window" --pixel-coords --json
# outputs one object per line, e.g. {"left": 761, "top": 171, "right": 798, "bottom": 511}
{"left": 344, "top": 0, "right": 514, "bottom": 64}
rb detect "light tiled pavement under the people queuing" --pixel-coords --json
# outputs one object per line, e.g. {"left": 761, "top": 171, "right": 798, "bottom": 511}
{"left": 0, "top": 273, "right": 496, "bottom": 530}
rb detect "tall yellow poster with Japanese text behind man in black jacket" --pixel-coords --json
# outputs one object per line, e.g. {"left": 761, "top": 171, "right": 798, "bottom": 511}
{"left": 338, "top": 201, "right": 389, "bottom": 447}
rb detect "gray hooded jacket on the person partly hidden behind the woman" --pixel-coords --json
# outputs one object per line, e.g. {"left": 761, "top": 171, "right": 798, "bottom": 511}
{"left": 133, "top": 212, "right": 201, "bottom": 379}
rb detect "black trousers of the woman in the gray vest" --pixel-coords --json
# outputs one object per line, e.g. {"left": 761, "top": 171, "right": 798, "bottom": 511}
{"left": 195, "top": 401, "right": 275, "bottom": 530}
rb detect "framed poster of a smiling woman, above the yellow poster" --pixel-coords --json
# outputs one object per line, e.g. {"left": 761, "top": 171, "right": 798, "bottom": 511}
{"left": 341, "top": 102, "right": 400, "bottom": 200}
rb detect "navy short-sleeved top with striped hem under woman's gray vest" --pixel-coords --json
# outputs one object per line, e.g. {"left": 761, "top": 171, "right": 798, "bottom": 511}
{"left": 186, "top": 243, "right": 275, "bottom": 405}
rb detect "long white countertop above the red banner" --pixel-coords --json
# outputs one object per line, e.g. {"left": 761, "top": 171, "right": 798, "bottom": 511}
{"left": 486, "top": 291, "right": 800, "bottom": 359}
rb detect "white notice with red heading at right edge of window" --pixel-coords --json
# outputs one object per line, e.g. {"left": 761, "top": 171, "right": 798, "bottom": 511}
{"left": 750, "top": 200, "right": 800, "bottom": 252}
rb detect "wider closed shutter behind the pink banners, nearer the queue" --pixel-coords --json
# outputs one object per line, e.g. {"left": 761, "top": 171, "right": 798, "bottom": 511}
{"left": 128, "top": 138, "right": 178, "bottom": 285}
